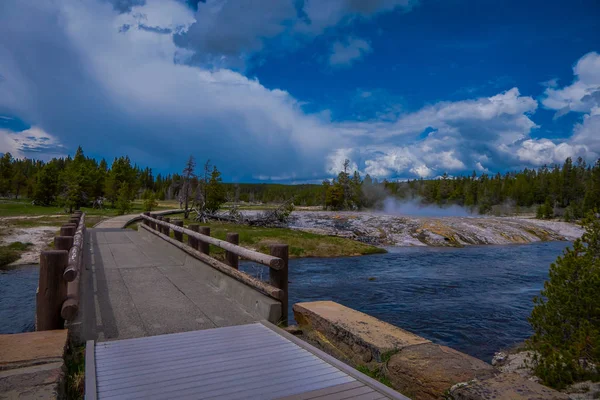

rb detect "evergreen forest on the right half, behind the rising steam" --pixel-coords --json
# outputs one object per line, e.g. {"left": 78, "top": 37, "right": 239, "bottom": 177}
{"left": 322, "top": 158, "right": 600, "bottom": 220}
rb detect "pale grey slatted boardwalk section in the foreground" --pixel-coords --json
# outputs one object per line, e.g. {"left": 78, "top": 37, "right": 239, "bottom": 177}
{"left": 86, "top": 323, "right": 406, "bottom": 400}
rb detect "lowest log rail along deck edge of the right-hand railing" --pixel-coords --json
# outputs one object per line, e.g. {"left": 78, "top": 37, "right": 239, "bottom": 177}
{"left": 140, "top": 225, "right": 284, "bottom": 301}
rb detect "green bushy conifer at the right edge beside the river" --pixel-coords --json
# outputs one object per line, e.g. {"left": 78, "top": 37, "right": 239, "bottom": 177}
{"left": 529, "top": 213, "right": 600, "bottom": 389}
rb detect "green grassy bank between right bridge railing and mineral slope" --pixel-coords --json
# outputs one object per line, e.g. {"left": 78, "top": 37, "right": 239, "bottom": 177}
{"left": 171, "top": 220, "right": 386, "bottom": 258}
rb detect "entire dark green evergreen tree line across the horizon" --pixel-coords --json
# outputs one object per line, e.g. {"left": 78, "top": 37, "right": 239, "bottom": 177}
{"left": 0, "top": 147, "right": 600, "bottom": 219}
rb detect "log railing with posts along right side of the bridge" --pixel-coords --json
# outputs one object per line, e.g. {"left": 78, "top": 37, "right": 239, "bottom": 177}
{"left": 140, "top": 212, "right": 288, "bottom": 322}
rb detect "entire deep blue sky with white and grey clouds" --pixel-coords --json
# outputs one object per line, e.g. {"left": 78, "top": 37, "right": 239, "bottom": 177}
{"left": 0, "top": 0, "right": 600, "bottom": 182}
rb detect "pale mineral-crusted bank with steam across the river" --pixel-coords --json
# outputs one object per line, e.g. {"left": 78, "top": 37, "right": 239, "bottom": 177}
{"left": 266, "top": 211, "right": 583, "bottom": 247}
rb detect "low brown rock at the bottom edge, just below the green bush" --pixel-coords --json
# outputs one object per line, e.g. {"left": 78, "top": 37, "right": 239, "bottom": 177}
{"left": 449, "top": 373, "right": 569, "bottom": 400}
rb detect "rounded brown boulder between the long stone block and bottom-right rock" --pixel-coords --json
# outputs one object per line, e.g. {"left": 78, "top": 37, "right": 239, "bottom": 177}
{"left": 387, "top": 343, "right": 494, "bottom": 399}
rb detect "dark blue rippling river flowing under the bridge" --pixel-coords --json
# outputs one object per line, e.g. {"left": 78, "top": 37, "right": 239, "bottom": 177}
{"left": 0, "top": 242, "right": 569, "bottom": 362}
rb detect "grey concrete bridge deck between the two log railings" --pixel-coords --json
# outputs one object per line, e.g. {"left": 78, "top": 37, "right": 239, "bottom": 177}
{"left": 81, "top": 229, "right": 260, "bottom": 341}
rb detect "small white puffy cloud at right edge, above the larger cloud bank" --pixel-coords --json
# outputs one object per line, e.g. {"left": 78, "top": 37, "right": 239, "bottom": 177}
{"left": 542, "top": 51, "right": 600, "bottom": 116}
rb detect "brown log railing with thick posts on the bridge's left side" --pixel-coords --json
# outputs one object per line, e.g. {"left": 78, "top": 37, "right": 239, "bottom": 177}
{"left": 36, "top": 211, "right": 85, "bottom": 331}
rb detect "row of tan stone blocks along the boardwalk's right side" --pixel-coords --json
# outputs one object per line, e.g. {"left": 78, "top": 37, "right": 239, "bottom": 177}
{"left": 293, "top": 301, "right": 568, "bottom": 400}
